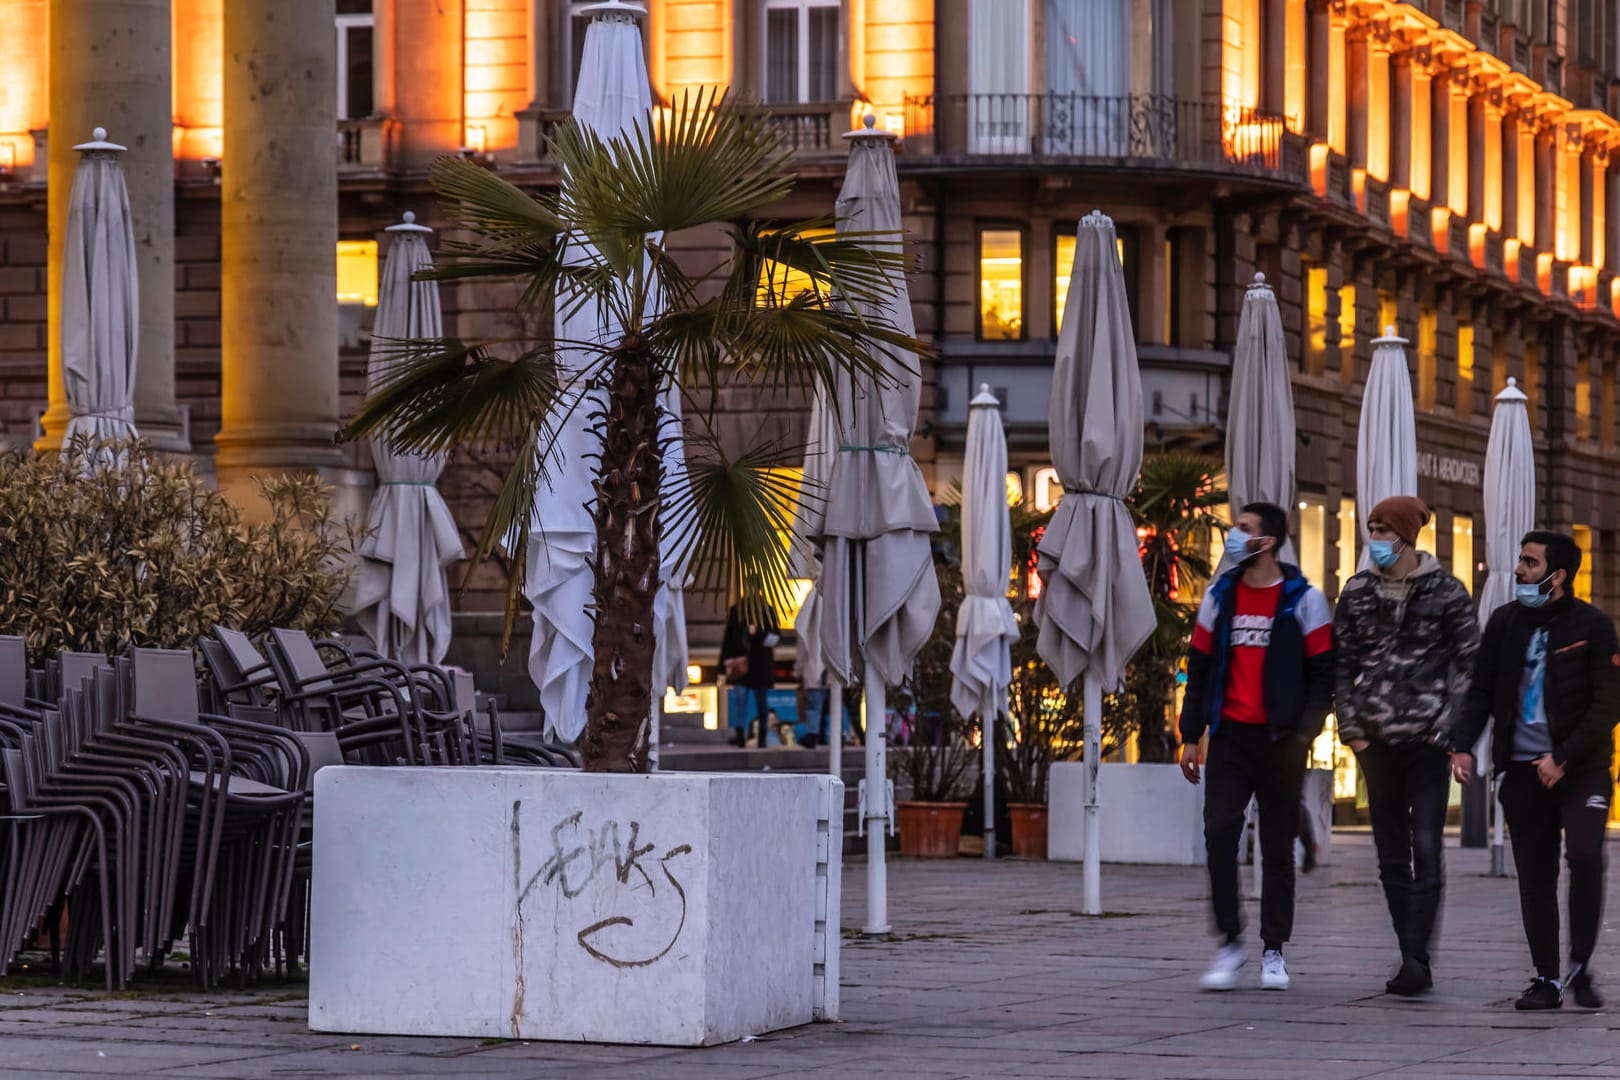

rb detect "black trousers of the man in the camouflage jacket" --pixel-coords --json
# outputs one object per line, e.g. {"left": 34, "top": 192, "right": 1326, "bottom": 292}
{"left": 1356, "top": 743, "right": 1452, "bottom": 965}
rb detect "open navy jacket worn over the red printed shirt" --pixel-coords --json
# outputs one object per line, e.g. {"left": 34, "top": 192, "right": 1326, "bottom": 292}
{"left": 1181, "top": 563, "right": 1333, "bottom": 743}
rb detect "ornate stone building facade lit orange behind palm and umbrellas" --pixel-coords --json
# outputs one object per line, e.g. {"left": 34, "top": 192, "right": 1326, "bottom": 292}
{"left": 0, "top": 0, "right": 1620, "bottom": 687}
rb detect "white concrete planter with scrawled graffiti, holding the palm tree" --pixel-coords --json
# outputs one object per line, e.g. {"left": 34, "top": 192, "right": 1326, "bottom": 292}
{"left": 309, "top": 767, "right": 844, "bottom": 1046}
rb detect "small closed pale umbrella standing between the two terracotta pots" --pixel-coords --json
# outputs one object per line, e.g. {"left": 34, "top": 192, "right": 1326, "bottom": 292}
{"left": 951, "top": 385, "right": 1017, "bottom": 858}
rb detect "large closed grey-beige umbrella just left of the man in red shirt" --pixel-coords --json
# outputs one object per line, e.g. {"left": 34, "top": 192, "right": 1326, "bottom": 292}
{"left": 1035, "top": 210, "right": 1157, "bottom": 915}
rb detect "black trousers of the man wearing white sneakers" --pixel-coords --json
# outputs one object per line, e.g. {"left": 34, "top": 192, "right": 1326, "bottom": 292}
{"left": 1204, "top": 722, "right": 1306, "bottom": 949}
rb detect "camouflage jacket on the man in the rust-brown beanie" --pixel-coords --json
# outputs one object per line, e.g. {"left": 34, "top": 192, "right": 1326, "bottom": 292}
{"left": 1333, "top": 552, "right": 1479, "bottom": 745}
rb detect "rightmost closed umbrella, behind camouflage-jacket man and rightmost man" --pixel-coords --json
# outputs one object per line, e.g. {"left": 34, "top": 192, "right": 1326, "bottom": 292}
{"left": 1474, "top": 379, "right": 1536, "bottom": 876}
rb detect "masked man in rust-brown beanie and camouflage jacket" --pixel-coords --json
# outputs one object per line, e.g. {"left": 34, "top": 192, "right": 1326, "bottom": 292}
{"left": 1333, "top": 495, "right": 1479, "bottom": 996}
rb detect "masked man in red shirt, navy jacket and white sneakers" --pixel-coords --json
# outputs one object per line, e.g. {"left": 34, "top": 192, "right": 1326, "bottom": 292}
{"left": 1181, "top": 502, "right": 1333, "bottom": 989}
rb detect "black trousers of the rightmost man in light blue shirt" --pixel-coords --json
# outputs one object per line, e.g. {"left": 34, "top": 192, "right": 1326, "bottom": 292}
{"left": 1502, "top": 761, "right": 1614, "bottom": 978}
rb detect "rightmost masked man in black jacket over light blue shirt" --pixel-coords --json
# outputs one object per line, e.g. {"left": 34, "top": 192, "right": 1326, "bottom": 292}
{"left": 1452, "top": 531, "right": 1620, "bottom": 1009}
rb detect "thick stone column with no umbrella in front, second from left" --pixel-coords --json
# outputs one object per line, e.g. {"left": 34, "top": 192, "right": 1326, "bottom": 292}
{"left": 215, "top": 0, "right": 342, "bottom": 507}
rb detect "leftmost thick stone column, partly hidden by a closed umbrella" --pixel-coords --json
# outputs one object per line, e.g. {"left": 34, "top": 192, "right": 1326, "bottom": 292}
{"left": 41, "top": 0, "right": 191, "bottom": 450}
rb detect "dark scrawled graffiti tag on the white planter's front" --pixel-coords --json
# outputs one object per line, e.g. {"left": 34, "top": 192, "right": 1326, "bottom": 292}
{"left": 514, "top": 806, "right": 692, "bottom": 968}
